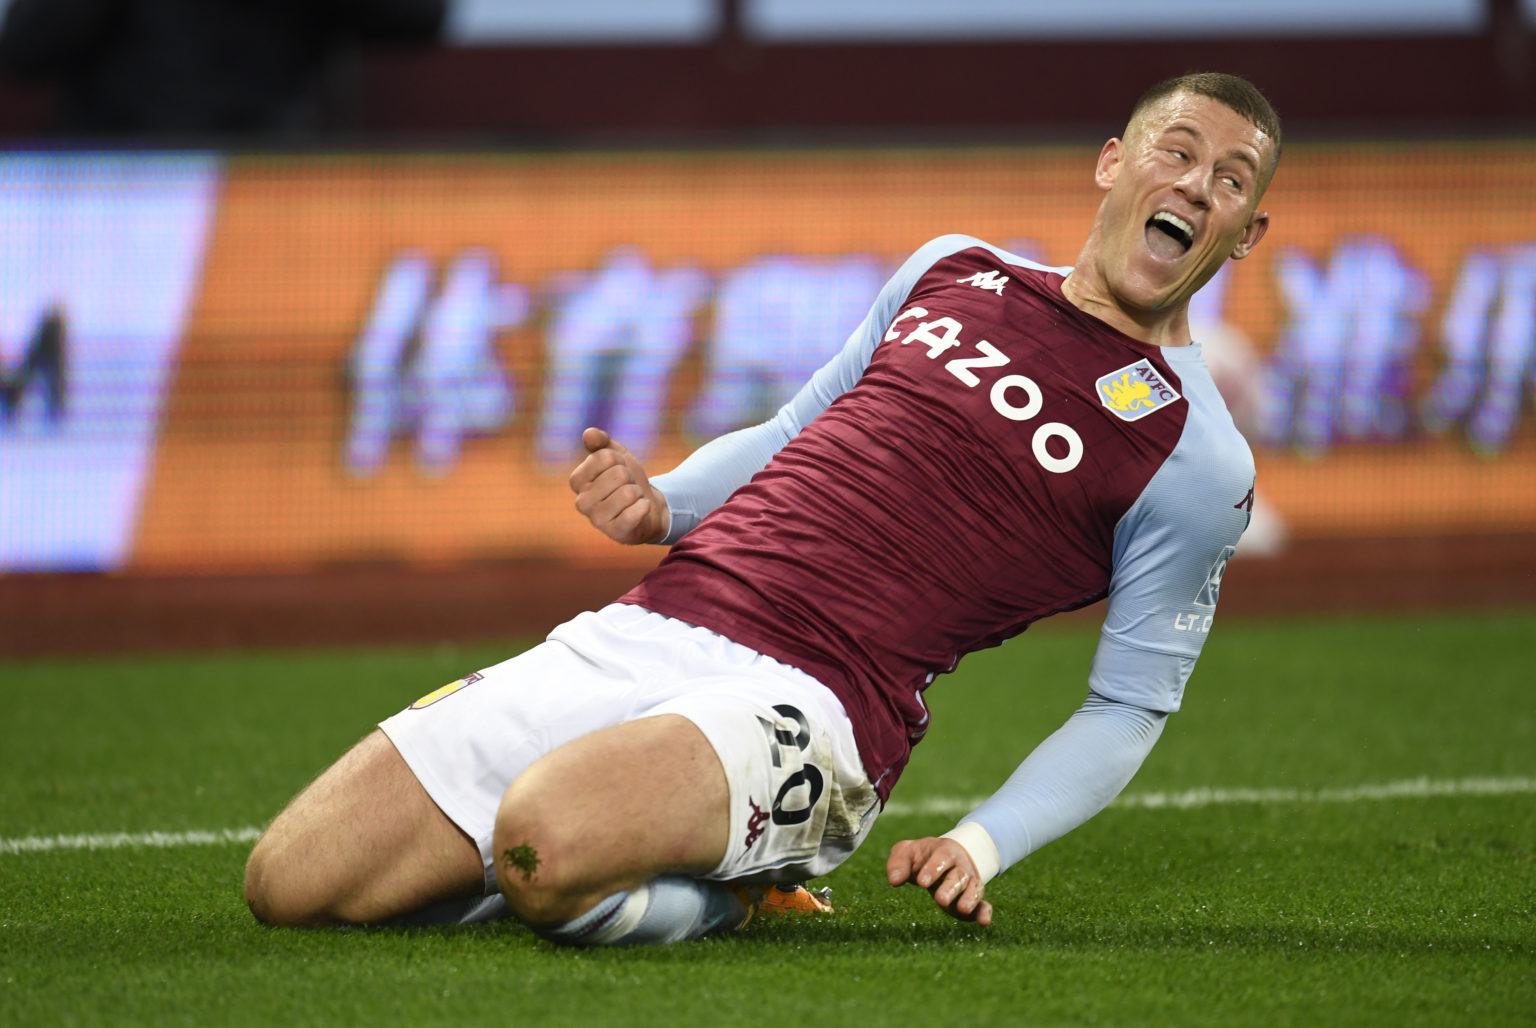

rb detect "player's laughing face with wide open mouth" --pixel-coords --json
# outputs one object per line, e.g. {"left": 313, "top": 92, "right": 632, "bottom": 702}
{"left": 1095, "top": 92, "right": 1273, "bottom": 313}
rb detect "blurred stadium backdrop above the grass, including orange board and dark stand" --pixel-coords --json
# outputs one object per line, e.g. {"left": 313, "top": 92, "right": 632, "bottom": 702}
{"left": 0, "top": 0, "right": 1536, "bottom": 655}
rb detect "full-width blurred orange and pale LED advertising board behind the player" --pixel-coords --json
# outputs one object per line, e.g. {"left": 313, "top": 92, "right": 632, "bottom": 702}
{"left": 0, "top": 141, "right": 1536, "bottom": 573}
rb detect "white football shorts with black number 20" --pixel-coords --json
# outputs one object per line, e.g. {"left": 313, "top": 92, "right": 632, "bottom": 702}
{"left": 379, "top": 604, "right": 879, "bottom": 894}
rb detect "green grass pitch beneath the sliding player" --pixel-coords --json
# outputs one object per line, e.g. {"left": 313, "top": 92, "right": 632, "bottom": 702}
{"left": 0, "top": 612, "right": 1536, "bottom": 1028}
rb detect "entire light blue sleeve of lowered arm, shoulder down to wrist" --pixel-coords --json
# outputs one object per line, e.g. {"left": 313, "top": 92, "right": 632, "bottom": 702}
{"left": 955, "top": 356, "right": 1253, "bottom": 873}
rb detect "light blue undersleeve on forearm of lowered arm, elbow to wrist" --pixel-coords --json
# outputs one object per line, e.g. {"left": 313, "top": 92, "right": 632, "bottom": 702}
{"left": 946, "top": 693, "right": 1167, "bottom": 879}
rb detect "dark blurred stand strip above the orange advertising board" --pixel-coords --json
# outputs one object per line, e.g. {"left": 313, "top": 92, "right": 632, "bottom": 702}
{"left": 0, "top": 0, "right": 1536, "bottom": 146}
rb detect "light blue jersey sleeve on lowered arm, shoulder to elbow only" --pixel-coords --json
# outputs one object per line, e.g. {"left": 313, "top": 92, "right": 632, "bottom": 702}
{"left": 1089, "top": 405, "right": 1253, "bottom": 713}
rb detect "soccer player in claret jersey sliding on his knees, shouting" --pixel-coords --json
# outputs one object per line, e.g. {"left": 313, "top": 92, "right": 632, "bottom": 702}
{"left": 246, "top": 74, "right": 1279, "bottom": 943}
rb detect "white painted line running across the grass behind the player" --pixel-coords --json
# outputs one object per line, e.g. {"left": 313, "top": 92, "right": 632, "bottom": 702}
{"left": 0, "top": 778, "right": 1536, "bottom": 856}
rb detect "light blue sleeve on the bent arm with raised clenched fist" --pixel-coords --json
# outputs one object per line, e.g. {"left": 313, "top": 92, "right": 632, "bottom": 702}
{"left": 651, "top": 235, "right": 983, "bottom": 544}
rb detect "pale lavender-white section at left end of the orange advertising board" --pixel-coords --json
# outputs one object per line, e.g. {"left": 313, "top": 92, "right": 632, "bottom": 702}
{"left": 0, "top": 155, "right": 218, "bottom": 570}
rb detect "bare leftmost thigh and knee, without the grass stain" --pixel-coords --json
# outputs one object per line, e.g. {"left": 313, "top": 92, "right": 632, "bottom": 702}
{"left": 246, "top": 730, "right": 485, "bottom": 925}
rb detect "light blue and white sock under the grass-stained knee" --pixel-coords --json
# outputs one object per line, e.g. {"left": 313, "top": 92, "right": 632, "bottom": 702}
{"left": 538, "top": 877, "right": 746, "bottom": 947}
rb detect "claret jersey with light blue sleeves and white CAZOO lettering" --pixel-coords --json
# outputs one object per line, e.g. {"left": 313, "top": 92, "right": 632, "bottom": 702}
{"left": 624, "top": 237, "right": 1253, "bottom": 798}
